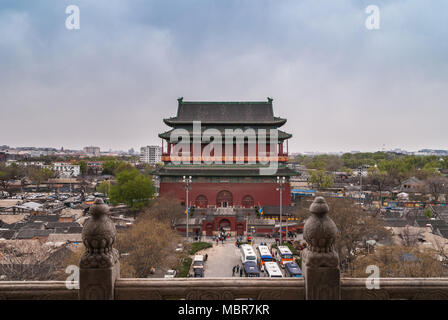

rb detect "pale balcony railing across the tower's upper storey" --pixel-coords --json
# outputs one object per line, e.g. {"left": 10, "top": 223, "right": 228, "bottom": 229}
{"left": 162, "top": 153, "right": 289, "bottom": 163}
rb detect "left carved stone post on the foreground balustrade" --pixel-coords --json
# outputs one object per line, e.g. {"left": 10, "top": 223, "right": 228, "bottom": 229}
{"left": 79, "top": 198, "right": 120, "bottom": 300}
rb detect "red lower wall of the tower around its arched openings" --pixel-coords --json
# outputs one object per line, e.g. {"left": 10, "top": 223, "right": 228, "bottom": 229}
{"left": 159, "top": 182, "right": 291, "bottom": 206}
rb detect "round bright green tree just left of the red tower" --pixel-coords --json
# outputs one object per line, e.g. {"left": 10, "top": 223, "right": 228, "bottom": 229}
{"left": 110, "top": 168, "right": 155, "bottom": 214}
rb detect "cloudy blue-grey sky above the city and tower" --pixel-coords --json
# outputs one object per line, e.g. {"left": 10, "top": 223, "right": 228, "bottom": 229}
{"left": 0, "top": 0, "right": 448, "bottom": 152}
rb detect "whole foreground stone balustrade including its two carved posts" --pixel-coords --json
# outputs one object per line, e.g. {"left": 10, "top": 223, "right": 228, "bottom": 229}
{"left": 0, "top": 197, "right": 448, "bottom": 300}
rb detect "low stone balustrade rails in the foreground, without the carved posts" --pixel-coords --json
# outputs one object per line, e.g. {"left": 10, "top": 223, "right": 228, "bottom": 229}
{"left": 0, "top": 278, "right": 448, "bottom": 300}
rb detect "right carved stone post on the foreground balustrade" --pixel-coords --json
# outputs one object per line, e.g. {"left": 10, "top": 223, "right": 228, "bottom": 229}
{"left": 302, "top": 197, "right": 341, "bottom": 300}
